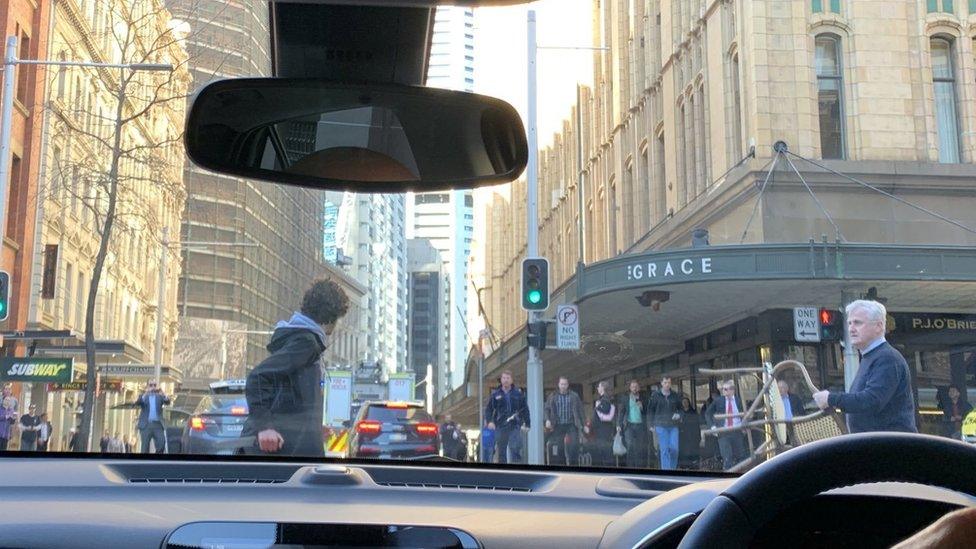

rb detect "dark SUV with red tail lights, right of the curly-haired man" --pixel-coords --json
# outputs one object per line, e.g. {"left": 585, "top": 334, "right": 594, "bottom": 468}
{"left": 349, "top": 401, "right": 440, "bottom": 459}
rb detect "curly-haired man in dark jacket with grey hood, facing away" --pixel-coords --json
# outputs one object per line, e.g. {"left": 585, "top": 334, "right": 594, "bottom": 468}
{"left": 241, "top": 280, "right": 349, "bottom": 456}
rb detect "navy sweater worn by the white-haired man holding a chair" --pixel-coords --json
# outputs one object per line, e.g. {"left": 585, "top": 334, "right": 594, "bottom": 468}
{"left": 828, "top": 342, "right": 918, "bottom": 433}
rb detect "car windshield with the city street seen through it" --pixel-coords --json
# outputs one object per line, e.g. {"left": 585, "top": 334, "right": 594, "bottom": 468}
{"left": 0, "top": 0, "right": 976, "bottom": 472}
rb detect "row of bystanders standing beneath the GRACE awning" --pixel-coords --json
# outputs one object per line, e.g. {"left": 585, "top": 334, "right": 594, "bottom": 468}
{"left": 472, "top": 371, "right": 745, "bottom": 469}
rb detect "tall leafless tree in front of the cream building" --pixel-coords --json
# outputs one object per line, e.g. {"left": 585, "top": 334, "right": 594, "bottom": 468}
{"left": 37, "top": 0, "right": 240, "bottom": 450}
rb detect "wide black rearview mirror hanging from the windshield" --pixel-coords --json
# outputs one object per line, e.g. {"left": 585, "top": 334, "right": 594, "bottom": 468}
{"left": 186, "top": 78, "right": 528, "bottom": 192}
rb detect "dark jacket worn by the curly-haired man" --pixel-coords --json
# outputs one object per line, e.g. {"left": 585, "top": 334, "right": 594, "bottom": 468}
{"left": 241, "top": 327, "right": 325, "bottom": 456}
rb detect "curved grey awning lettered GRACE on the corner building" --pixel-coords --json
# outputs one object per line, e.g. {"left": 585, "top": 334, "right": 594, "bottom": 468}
{"left": 436, "top": 243, "right": 976, "bottom": 421}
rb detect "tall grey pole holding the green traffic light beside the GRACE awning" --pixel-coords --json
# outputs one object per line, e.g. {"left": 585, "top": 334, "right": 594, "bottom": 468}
{"left": 525, "top": 10, "right": 545, "bottom": 465}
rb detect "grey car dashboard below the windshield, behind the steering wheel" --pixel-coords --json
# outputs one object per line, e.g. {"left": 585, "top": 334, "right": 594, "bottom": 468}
{"left": 0, "top": 457, "right": 976, "bottom": 549}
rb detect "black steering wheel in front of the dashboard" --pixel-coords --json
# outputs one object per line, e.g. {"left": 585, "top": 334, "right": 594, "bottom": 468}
{"left": 678, "top": 433, "right": 976, "bottom": 549}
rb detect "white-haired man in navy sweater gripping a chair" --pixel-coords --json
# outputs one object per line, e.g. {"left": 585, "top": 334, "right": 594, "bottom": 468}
{"left": 813, "top": 300, "right": 918, "bottom": 433}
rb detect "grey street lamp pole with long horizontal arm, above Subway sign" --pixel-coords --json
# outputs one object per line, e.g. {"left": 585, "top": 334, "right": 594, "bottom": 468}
{"left": 0, "top": 36, "right": 175, "bottom": 268}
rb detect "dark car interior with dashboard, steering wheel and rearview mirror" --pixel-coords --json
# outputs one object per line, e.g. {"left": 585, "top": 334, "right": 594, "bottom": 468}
{"left": 0, "top": 0, "right": 976, "bottom": 549}
